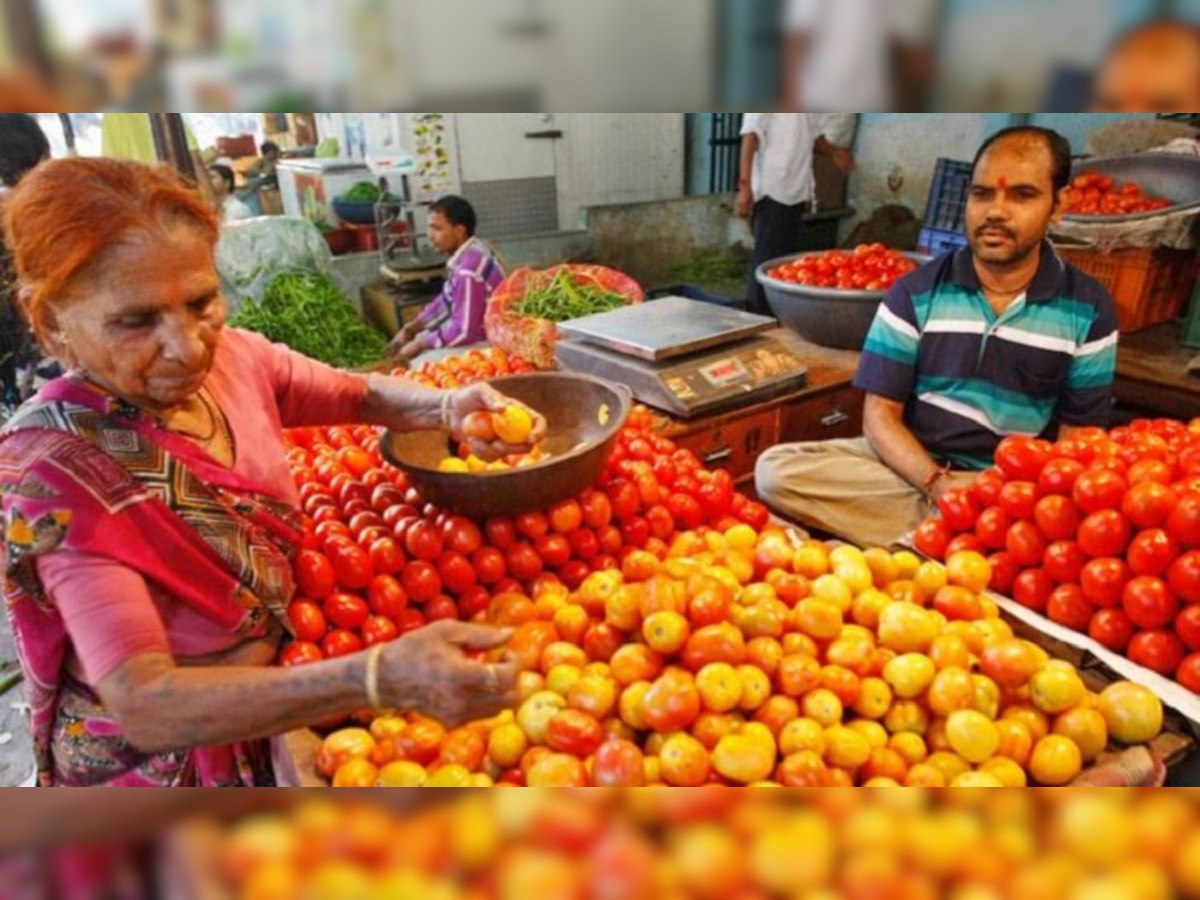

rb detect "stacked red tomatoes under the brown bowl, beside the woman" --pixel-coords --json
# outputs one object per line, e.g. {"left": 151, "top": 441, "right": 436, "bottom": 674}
{"left": 281, "top": 358, "right": 768, "bottom": 665}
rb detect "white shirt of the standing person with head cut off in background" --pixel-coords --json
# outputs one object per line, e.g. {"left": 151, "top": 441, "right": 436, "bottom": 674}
{"left": 742, "top": 113, "right": 817, "bottom": 206}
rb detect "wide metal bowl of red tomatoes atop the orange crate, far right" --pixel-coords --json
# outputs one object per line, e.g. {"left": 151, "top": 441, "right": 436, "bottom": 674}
{"left": 1063, "top": 154, "right": 1200, "bottom": 223}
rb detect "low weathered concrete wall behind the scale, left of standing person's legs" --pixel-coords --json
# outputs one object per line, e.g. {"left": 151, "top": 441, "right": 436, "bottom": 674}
{"left": 587, "top": 194, "right": 750, "bottom": 286}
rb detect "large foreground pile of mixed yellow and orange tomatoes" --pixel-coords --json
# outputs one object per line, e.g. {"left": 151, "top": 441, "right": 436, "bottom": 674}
{"left": 317, "top": 542, "right": 1163, "bottom": 787}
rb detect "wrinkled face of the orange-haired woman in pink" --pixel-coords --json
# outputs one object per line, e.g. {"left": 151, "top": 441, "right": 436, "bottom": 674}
{"left": 48, "top": 224, "right": 226, "bottom": 413}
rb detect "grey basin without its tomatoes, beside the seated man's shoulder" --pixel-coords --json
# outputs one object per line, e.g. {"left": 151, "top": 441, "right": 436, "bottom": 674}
{"left": 755, "top": 251, "right": 930, "bottom": 350}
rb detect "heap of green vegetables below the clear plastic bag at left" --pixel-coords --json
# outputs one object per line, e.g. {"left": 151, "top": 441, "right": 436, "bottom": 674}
{"left": 229, "top": 272, "right": 388, "bottom": 368}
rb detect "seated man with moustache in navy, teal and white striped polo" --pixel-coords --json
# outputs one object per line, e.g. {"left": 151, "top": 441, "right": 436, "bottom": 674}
{"left": 756, "top": 127, "right": 1117, "bottom": 545}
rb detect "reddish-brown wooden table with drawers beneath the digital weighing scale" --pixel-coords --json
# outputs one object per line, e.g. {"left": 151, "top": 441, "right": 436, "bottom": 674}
{"left": 655, "top": 330, "right": 864, "bottom": 488}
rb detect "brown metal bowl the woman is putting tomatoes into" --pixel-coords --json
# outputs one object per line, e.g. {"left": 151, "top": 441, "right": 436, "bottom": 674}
{"left": 379, "top": 372, "right": 632, "bottom": 518}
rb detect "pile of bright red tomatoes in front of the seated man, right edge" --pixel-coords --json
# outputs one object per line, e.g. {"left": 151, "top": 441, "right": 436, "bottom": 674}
{"left": 916, "top": 419, "right": 1200, "bottom": 692}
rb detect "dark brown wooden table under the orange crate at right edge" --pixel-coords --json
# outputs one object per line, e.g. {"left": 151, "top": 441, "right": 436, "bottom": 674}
{"left": 1114, "top": 322, "right": 1200, "bottom": 419}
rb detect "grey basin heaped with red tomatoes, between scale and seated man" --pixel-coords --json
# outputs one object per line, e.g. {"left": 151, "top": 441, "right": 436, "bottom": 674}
{"left": 755, "top": 244, "right": 929, "bottom": 350}
